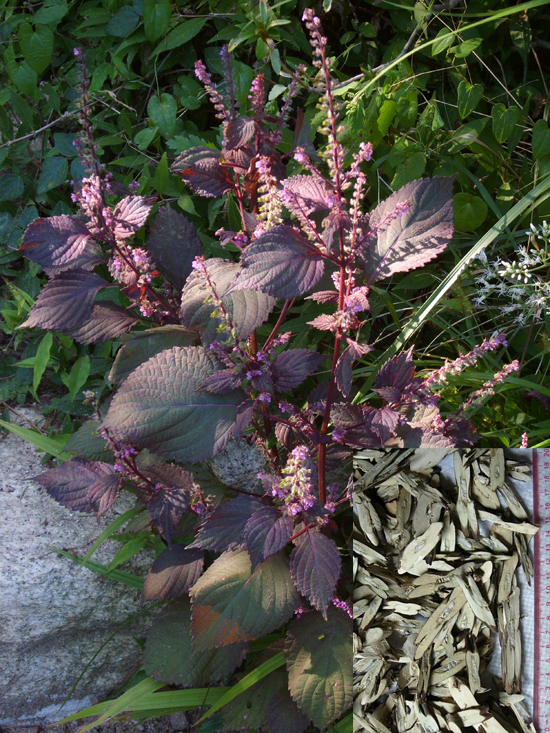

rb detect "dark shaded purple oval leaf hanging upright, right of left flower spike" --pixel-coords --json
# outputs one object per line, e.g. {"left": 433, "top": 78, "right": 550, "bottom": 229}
{"left": 147, "top": 206, "right": 202, "bottom": 292}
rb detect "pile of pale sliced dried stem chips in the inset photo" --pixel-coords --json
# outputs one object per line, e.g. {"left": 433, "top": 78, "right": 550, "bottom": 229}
{"left": 353, "top": 449, "right": 537, "bottom": 733}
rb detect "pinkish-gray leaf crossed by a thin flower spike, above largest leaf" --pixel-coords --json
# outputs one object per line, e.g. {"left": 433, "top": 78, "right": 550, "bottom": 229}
{"left": 180, "top": 257, "right": 276, "bottom": 345}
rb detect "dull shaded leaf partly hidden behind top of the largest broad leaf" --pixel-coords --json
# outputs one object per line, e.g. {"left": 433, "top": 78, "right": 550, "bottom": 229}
{"left": 109, "top": 326, "right": 195, "bottom": 384}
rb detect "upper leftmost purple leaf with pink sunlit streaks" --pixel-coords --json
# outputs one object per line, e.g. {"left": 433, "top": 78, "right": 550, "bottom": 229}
{"left": 21, "top": 216, "right": 102, "bottom": 275}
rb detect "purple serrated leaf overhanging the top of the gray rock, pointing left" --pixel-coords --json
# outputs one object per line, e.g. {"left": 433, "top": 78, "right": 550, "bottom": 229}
{"left": 34, "top": 458, "right": 118, "bottom": 512}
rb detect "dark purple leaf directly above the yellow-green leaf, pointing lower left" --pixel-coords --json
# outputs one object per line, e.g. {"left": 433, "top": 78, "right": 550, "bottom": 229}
{"left": 190, "top": 494, "right": 262, "bottom": 552}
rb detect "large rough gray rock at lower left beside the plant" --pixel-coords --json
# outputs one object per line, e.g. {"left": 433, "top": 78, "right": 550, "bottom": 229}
{"left": 0, "top": 409, "right": 160, "bottom": 725}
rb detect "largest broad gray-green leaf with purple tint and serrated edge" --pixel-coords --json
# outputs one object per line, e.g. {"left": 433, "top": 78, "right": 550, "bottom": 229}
{"left": 104, "top": 347, "right": 244, "bottom": 463}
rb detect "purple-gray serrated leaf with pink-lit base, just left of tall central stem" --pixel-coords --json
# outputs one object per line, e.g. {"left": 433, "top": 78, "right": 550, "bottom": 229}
{"left": 228, "top": 225, "right": 325, "bottom": 298}
